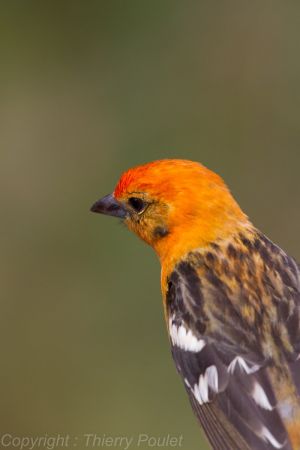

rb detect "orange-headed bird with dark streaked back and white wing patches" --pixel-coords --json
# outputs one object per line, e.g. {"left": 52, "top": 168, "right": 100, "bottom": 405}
{"left": 91, "top": 159, "right": 300, "bottom": 450}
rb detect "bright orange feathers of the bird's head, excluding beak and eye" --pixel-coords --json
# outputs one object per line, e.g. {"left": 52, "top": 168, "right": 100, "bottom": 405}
{"left": 114, "top": 159, "right": 247, "bottom": 290}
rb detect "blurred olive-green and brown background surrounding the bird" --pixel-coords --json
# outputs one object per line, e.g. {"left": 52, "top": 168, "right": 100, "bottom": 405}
{"left": 0, "top": 0, "right": 300, "bottom": 450}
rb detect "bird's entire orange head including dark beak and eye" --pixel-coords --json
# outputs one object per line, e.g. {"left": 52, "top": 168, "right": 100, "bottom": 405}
{"left": 91, "top": 159, "right": 247, "bottom": 260}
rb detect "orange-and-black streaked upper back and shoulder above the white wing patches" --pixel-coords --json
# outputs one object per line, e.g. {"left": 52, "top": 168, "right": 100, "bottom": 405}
{"left": 165, "top": 229, "right": 300, "bottom": 356}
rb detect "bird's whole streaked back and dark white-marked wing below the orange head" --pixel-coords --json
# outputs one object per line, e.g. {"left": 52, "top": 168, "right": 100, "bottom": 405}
{"left": 166, "top": 228, "right": 300, "bottom": 449}
